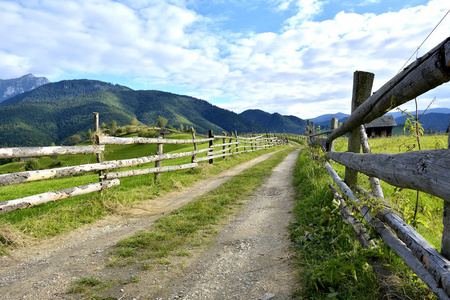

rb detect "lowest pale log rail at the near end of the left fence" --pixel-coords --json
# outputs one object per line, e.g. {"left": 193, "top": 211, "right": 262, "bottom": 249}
{"left": 0, "top": 179, "right": 120, "bottom": 215}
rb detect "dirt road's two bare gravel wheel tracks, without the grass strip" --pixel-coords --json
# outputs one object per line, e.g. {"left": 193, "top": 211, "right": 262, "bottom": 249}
{"left": 0, "top": 151, "right": 298, "bottom": 300}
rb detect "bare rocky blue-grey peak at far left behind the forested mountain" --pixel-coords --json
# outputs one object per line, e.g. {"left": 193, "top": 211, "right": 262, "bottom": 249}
{"left": 0, "top": 74, "right": 49, "bottom": 103}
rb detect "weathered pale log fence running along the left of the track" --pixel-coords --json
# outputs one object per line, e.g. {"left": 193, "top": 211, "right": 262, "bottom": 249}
{"left": 0, "top": 117, "right": 285, "bottom": 214}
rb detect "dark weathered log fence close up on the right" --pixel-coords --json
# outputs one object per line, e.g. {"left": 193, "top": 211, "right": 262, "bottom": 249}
{"left": 307, "top": 38, "right": 450, "bottom": 299}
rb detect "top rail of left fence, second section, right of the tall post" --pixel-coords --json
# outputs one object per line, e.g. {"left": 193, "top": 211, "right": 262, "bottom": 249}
{"left": 98, "top": 136, "right": 214, "bottom": 145}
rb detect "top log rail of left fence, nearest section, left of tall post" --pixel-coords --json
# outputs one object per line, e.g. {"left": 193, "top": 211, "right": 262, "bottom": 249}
{"left": 0, "top": 145, "right": 105, "bottom": 159}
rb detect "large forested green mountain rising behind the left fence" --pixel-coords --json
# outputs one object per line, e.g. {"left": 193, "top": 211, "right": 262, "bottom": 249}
{"left": 0, "top": 80, "right": 265, "bottom": 147}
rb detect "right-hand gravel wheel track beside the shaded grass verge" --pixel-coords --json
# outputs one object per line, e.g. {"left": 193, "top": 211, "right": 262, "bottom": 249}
{"left": 151, "top": 150, "right": 299, "bottom": 300}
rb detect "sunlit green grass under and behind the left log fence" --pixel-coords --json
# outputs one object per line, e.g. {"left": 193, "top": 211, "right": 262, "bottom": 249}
{"left": 0, "top": 134, "right": 286, "bottom": 254}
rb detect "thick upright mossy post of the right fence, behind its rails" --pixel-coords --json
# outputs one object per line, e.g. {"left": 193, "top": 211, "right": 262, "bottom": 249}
{"left": 344, "top": 71, "right": 375, "bottom": 188}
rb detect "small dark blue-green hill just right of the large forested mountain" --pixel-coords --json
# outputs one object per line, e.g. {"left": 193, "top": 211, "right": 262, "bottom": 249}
{"left": 240, "top": 109, "right": 306, "bottom": 134}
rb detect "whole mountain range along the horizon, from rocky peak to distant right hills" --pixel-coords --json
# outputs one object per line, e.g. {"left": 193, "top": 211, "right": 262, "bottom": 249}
{"left": 0, "top": 74, "right": 450, "bottom": 147}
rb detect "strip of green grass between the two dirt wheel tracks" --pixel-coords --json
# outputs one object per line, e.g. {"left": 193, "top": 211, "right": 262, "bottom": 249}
{"left": 67, "top": 148, "right": 294, "bottom": 297}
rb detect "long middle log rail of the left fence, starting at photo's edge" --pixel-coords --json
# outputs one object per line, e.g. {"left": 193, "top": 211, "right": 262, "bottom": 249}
{"left": 0, "top": 148, "right": 211, "bottom": 186}
